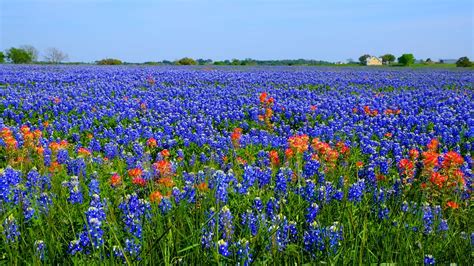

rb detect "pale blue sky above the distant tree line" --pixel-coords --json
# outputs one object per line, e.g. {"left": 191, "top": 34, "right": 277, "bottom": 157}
{"left": 0, "top": 0, "right": 474, "bottom": 62}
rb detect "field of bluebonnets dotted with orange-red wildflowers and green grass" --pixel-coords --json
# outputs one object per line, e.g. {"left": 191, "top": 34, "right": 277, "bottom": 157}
{"left": 0, "top": 65, "right": 474, "bottom": 265}
